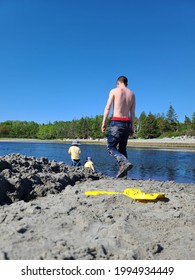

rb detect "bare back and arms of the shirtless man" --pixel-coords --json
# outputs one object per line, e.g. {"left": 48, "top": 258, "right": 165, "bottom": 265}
{"left": 102, "top": 82, "right": 135, "bottom": 132}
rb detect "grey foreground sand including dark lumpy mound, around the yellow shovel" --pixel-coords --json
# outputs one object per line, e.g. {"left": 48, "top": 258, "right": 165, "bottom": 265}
{"left": 0, "top": 154, "right": 195, "bottom": 260}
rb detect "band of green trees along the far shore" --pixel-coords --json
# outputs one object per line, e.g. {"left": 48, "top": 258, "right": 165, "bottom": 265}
{"left": 0, "top": 105, "right": 195, "bottom": 140}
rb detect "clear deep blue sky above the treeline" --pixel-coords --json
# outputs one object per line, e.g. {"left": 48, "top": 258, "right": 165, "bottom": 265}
{"left": 0, "top": 0, "right": 195, "bottom": 123}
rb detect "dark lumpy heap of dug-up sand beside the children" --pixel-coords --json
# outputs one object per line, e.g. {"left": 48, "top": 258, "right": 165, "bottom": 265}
{"left": 0, "top": 154, "right": 104, "bottom": 205}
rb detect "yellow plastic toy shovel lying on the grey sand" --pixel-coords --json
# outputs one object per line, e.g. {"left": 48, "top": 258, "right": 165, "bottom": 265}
{"left": 85, "top": 188, "right": 165, "bottom": 200}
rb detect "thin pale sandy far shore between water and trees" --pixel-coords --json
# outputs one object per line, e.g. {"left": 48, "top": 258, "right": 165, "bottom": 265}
{"left": 0, "top": 136, "right": 195, "bottom": 149}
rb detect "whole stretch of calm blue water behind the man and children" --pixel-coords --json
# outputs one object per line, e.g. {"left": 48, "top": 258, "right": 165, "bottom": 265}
{"left": 0, "top": 142, "right": 195, "bottom": 183}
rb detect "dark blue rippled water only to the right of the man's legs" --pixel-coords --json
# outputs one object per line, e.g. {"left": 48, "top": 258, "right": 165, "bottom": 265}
{"left": 128, "top": 149, "right": 195, "bottom": 183}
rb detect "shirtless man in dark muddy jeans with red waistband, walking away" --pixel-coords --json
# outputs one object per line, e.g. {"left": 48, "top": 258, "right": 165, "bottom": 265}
{"left": 102, "top": 76, "right": 135, "bottom": 178}
